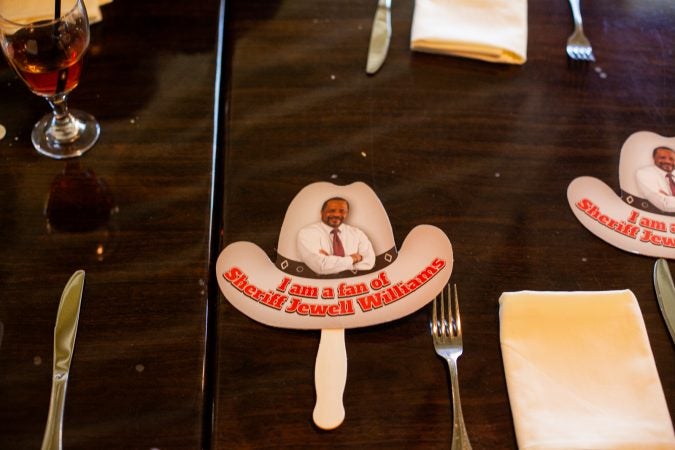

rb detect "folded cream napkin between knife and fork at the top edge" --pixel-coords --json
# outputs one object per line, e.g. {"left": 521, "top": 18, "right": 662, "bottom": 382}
{"left": 410, "top": 0, "right": 527, "bottom": 64}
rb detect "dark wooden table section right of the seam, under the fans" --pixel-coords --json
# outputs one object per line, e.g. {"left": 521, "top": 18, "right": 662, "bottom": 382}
{"left": 213, "top": 0, "right": 675, "bottom": 449}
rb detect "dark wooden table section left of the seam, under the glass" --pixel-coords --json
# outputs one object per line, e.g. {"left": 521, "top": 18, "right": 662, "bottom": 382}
{"left": 0, "top": 0, "right": 219, "bottom": 450}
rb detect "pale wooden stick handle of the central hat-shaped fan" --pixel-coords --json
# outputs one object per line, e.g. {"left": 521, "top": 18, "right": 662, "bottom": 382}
{"left": 313, "top": 329, "right": 347, "bottom": 430}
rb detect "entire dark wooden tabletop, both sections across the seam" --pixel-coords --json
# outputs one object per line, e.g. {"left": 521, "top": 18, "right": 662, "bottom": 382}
{"left": 0, "top": 0, "right": 675, "bottom": 450}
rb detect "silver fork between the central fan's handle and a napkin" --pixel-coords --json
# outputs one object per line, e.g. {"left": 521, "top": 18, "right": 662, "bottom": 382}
{"left": 429, "top": 284, "right": 471, "bottom": 450}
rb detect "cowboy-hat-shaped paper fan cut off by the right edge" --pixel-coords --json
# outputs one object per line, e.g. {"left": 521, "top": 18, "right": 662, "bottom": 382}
{"left": 567, "top": 131, "right": 675, "bottom": 259}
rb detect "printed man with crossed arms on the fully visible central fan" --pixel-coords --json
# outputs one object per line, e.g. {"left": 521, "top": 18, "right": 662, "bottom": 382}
{"left": 297, "top": 197, "right": 375, "bottom": 275}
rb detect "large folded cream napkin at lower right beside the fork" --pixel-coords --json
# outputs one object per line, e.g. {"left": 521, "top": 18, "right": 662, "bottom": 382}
{"left": 499, "top": 290, "right": 675, "bottom": 450}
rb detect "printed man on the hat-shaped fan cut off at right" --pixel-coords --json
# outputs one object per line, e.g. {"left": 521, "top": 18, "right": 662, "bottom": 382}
{"left": 635, "top": 147, "right": 675, "bottom": 213}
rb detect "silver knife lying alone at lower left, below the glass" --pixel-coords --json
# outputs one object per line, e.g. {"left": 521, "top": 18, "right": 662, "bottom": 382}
{"left": 41, "top": 270, "right": 84, "bottom": 450}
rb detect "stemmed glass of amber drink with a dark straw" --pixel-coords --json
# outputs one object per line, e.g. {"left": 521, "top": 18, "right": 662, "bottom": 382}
{"left": 0, "top": 0, "right": 100, "bottom": 159}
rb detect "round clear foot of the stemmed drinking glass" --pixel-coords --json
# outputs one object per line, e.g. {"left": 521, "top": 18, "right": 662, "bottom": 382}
{"left": 31, "top": 109, "right": 101, "bottom": 159}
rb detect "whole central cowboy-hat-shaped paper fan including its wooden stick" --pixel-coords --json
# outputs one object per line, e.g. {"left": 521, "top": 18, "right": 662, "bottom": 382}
{"left": 216, "top": 182, "right": 453, "bottom": 429}
